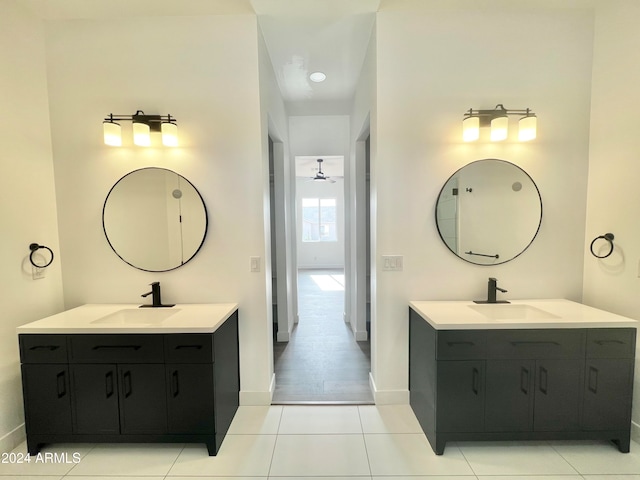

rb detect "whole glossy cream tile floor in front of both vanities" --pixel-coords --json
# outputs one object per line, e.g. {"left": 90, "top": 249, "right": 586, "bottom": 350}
{"left": 0, "top": 405, "right": 640, "bottom": 480}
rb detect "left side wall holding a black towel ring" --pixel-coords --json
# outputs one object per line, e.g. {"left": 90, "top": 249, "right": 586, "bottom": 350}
{"left": 0, "top": 0, "right": 63, "bottom": 452}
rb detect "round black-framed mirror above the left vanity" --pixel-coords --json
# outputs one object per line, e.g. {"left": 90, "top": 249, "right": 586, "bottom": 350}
{"left": 102, "top": 167, "right": 208, "bottom": 272}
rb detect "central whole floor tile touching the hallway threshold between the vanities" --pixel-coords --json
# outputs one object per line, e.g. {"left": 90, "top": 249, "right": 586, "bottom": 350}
{"left": 278, "top": 405, "right": 362, "bottom": 435}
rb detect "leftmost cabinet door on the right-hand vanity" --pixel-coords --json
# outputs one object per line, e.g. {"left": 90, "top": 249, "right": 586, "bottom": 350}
{"left": 436, "top": 360, "right": 484, "bottom": 432}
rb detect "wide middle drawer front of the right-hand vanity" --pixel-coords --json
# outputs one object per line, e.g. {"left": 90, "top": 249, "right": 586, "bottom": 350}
{"left": 487, "top": 329, "right": 585, "bottom": 358}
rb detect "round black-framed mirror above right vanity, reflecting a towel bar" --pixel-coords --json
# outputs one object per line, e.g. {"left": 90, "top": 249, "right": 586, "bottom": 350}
{"left": 436, "top": 158, "right": 542, "bottom": 265}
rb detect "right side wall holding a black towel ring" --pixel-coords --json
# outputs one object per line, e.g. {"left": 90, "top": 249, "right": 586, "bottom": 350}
{"left": 582, "top": 0, "right": 640, "bottom": 438}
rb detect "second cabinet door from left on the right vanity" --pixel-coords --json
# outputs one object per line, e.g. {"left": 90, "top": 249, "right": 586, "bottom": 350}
{"left": 485, "top": 359, "right": 535, "bottom": 432}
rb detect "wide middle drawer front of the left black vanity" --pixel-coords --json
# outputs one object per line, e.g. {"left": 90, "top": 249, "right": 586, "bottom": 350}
{"left": 69, "top": 334, "right": 164, "bottom": 363}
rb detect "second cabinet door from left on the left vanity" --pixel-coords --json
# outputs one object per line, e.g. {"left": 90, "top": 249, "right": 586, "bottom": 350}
{"left": 71, "top": 364, "right": 120, "bottom": 434}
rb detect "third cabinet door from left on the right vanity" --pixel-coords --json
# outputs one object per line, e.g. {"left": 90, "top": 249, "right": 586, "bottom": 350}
{"left": 533, "top": 358, "right": 582, "bottom": 432}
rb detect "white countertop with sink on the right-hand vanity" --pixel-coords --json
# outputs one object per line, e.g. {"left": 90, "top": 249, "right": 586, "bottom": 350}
{"left": 409, "top": 299, "right": 638, "bottom": 330}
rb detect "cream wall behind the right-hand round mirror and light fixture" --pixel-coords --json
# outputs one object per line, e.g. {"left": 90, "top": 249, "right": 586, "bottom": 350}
{"left": 371, "top": 0, "right": 593, "bottom": 403}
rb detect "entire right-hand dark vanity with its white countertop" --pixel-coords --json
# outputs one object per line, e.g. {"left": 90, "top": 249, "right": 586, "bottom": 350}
{"left": 409, "top": 300, "right": 637, "bottom": 455}
